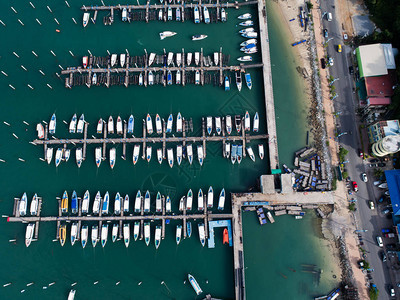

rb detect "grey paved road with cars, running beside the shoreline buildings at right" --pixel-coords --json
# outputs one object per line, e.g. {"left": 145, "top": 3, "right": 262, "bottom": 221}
{"left": 320, "top": 0, "right": 391, "bottom": 299}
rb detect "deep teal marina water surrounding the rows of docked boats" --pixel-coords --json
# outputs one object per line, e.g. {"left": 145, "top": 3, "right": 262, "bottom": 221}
{"left": 0, "top": 0, "right": 338, "bottom": 299}
